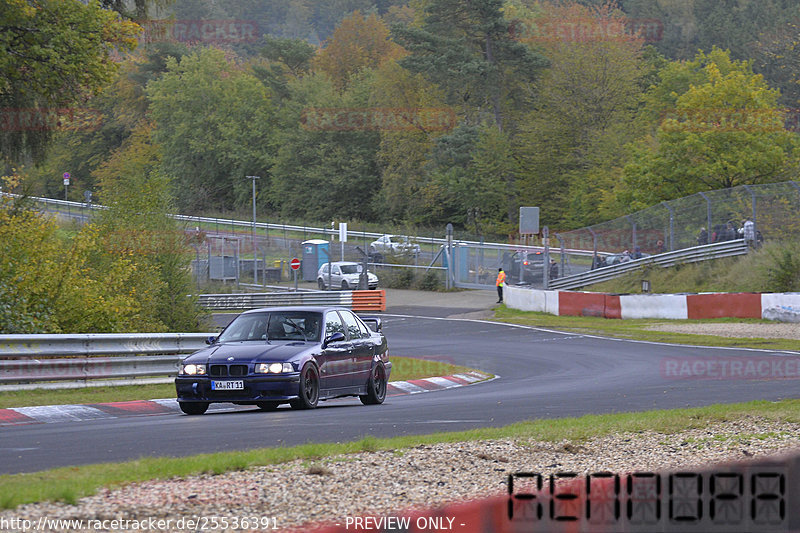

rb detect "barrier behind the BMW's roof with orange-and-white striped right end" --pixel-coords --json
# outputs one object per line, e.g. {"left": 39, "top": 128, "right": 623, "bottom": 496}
{"left": 199, "top": 290, "right": 386, "bottom": 311}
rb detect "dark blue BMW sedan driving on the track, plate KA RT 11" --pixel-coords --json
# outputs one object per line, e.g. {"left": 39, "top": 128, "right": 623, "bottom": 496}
{"left": 175, "top": 307, "right": 392, "bottom": 415}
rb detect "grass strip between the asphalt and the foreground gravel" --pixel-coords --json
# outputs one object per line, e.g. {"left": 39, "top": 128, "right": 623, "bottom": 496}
{"left": 0, "top": 400, "right": 800, "bottom": 509}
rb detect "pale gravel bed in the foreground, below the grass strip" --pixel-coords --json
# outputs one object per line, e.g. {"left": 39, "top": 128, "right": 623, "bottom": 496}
{"left": 0, "top": 418, "right": 800, "bottom": 530}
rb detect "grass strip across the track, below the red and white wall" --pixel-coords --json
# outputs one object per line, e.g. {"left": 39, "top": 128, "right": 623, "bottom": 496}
{"left": 495, "top": 306, "right": 800, "bottom": 351}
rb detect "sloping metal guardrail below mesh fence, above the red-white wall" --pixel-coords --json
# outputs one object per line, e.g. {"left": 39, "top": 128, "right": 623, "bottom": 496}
{"left": 548, "top": 239, "right": 750, "bottom": 289}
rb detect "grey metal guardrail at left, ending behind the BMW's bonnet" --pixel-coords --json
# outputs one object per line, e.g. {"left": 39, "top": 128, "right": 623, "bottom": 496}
{"left": 0, "top": 333, "right": 212, "bottom": 391}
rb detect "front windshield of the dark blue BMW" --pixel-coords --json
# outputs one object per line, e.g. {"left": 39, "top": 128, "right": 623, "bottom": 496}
{"left": 217, "top": 311, "right": 321, "bottom": 343}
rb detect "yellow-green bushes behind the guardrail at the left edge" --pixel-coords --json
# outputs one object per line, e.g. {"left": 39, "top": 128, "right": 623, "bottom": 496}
{"left": 0, "top": 175, "right": 165, "bottom": 333}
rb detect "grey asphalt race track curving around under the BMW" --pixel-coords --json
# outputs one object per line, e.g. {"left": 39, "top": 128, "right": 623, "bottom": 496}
{"left": 0, "top": 315, "right": 800, "bottom": 473}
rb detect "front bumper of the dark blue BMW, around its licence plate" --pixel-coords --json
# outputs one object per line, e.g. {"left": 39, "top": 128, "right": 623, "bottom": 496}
{"left": 175, "top": 372, "right": 300, "bottom": 403}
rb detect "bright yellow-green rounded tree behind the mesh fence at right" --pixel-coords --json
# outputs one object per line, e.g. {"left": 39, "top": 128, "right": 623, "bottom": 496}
{"left": 625, "top": 48, "right": 798, "bottom": 208}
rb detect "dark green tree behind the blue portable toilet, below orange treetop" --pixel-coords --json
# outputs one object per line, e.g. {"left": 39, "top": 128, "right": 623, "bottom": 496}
{"left": 269, "top": 74, "right": 380, "bottom": 220}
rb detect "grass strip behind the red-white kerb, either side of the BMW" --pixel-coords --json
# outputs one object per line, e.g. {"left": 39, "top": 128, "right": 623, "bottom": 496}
{"left": 0, "top": 356, "right": 473, "bottom": 409}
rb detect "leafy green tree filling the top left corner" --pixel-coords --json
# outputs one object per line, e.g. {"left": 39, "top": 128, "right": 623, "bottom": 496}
{"left": 0, "top": 0, "right": 139, "bottom": 162}
